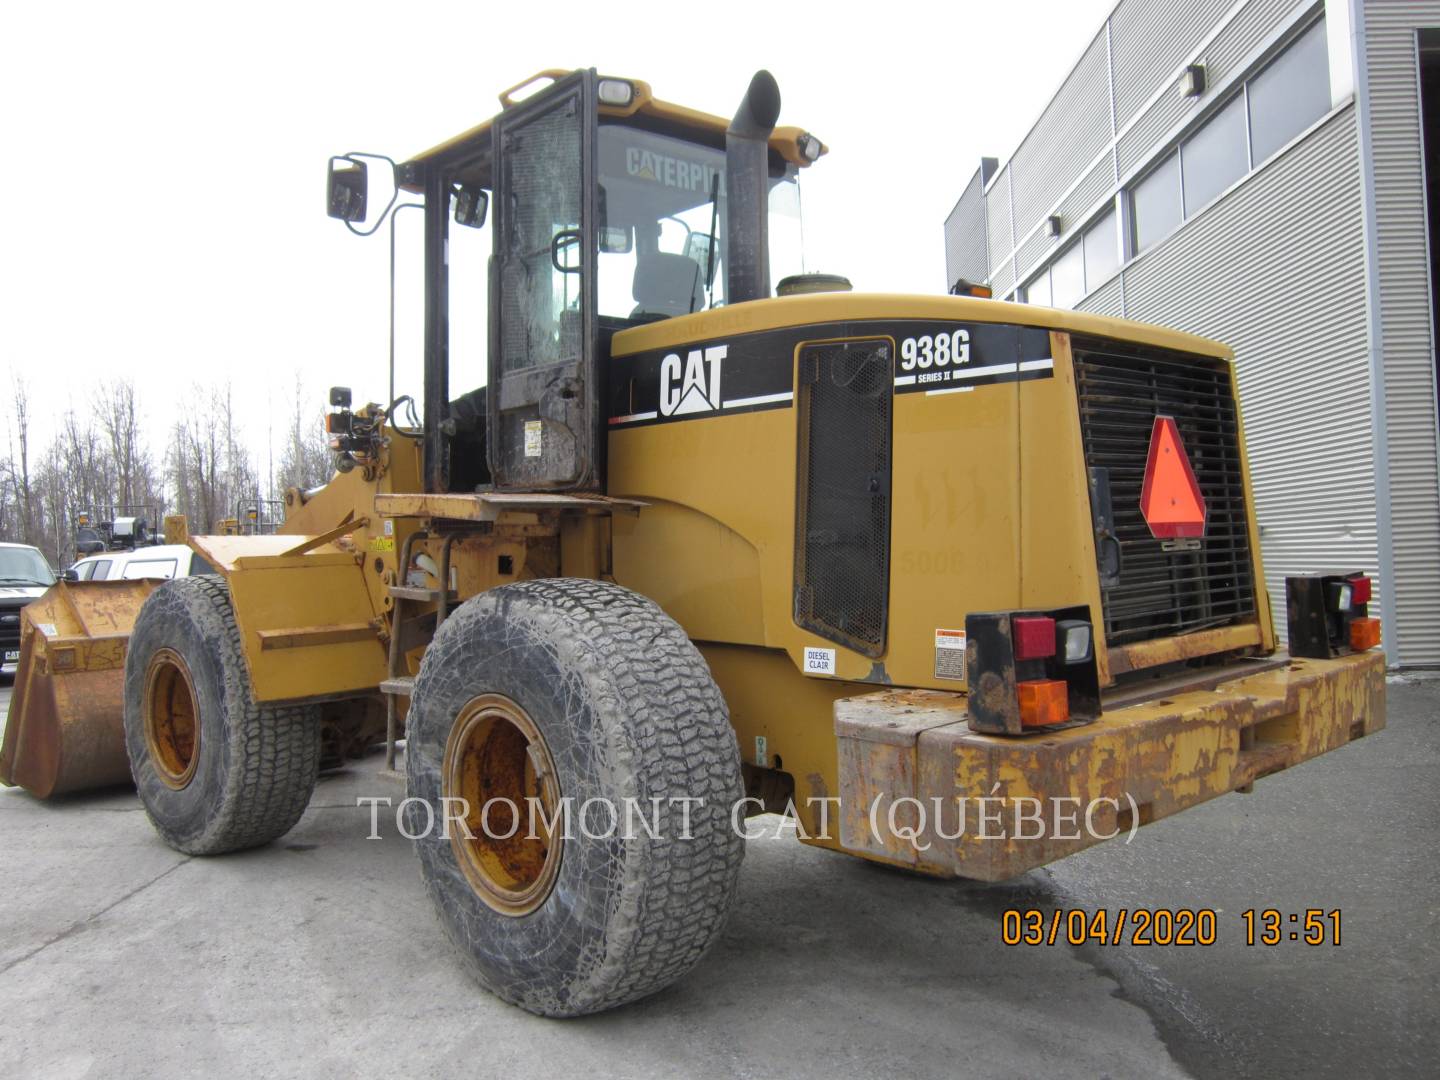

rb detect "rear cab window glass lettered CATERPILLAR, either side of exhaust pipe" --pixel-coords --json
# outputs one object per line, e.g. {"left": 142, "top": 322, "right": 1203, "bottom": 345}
{"left": 596, "top": 124, "right": 804, "bottom": 321}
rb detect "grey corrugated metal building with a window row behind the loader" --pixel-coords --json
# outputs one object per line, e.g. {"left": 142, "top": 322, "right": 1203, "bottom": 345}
{"left": 945, "top": 0, "right": 1440, "bottom": 667}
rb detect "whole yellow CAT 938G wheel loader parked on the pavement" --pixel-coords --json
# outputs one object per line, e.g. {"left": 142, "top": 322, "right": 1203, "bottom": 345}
{"left": 4, "top": 71, "right": 1384, "bottom": 1015}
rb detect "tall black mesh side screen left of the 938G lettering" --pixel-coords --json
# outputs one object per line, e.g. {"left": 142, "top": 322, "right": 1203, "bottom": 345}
{"left": 795, "top": 340, "right": 894, "bottom": 657}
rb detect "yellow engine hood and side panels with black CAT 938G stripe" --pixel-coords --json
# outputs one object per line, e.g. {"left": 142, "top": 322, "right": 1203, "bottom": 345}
{"left": 608, "top": 294, "right": 1274, "bottom": 854}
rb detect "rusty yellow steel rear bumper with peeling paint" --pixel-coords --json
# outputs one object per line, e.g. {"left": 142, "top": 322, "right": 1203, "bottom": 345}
{"left": 835, "top": 649, "right": 1385, "bottom": 881}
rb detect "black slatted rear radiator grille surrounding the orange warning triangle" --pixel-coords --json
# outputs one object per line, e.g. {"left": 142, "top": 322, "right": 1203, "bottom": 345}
{"left": 1073, "top": 337, "right": 1256, "bottom": 645}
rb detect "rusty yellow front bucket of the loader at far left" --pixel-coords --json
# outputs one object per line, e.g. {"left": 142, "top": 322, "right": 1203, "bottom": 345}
{"left": 0, "top": 580, "right": 161, "bottom": 799}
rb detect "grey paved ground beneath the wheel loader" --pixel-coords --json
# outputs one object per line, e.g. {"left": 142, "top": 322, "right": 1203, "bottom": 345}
{"left": 0, "top": 681, "right": 1440, "bottom": 1080}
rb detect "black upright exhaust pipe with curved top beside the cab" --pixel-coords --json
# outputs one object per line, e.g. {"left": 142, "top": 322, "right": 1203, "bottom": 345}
{"left": 724, "top": 71, "right": 780, "bottom": 304}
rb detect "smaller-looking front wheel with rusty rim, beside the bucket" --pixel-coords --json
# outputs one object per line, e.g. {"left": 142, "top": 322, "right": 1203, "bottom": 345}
{"left": 125, "top": 576, "right": 320, "bottom": 855}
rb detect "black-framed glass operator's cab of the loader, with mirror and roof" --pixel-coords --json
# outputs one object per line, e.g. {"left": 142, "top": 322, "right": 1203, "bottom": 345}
{"left": 377, "top": 71, "right": 822, "bottom": 492}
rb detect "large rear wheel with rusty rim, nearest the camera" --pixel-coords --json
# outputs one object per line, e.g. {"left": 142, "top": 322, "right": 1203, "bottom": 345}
{"left": 406, "top": 579, "right": 744, "bottom": 1017}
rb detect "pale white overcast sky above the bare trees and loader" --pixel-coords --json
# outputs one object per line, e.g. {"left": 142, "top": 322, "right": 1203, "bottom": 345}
{"left": 0, "top": 0, "right": 1113, "bottom": 460}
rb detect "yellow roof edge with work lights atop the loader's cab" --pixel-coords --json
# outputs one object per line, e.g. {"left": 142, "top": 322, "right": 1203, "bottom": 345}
{"left": 400, "top": 68, "right": 829, "bottom": 193}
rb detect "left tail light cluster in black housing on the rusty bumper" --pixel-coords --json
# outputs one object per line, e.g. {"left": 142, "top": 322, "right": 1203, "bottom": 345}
{"left": 965, "top": 608, "right": 1100, "bottom": 734}
